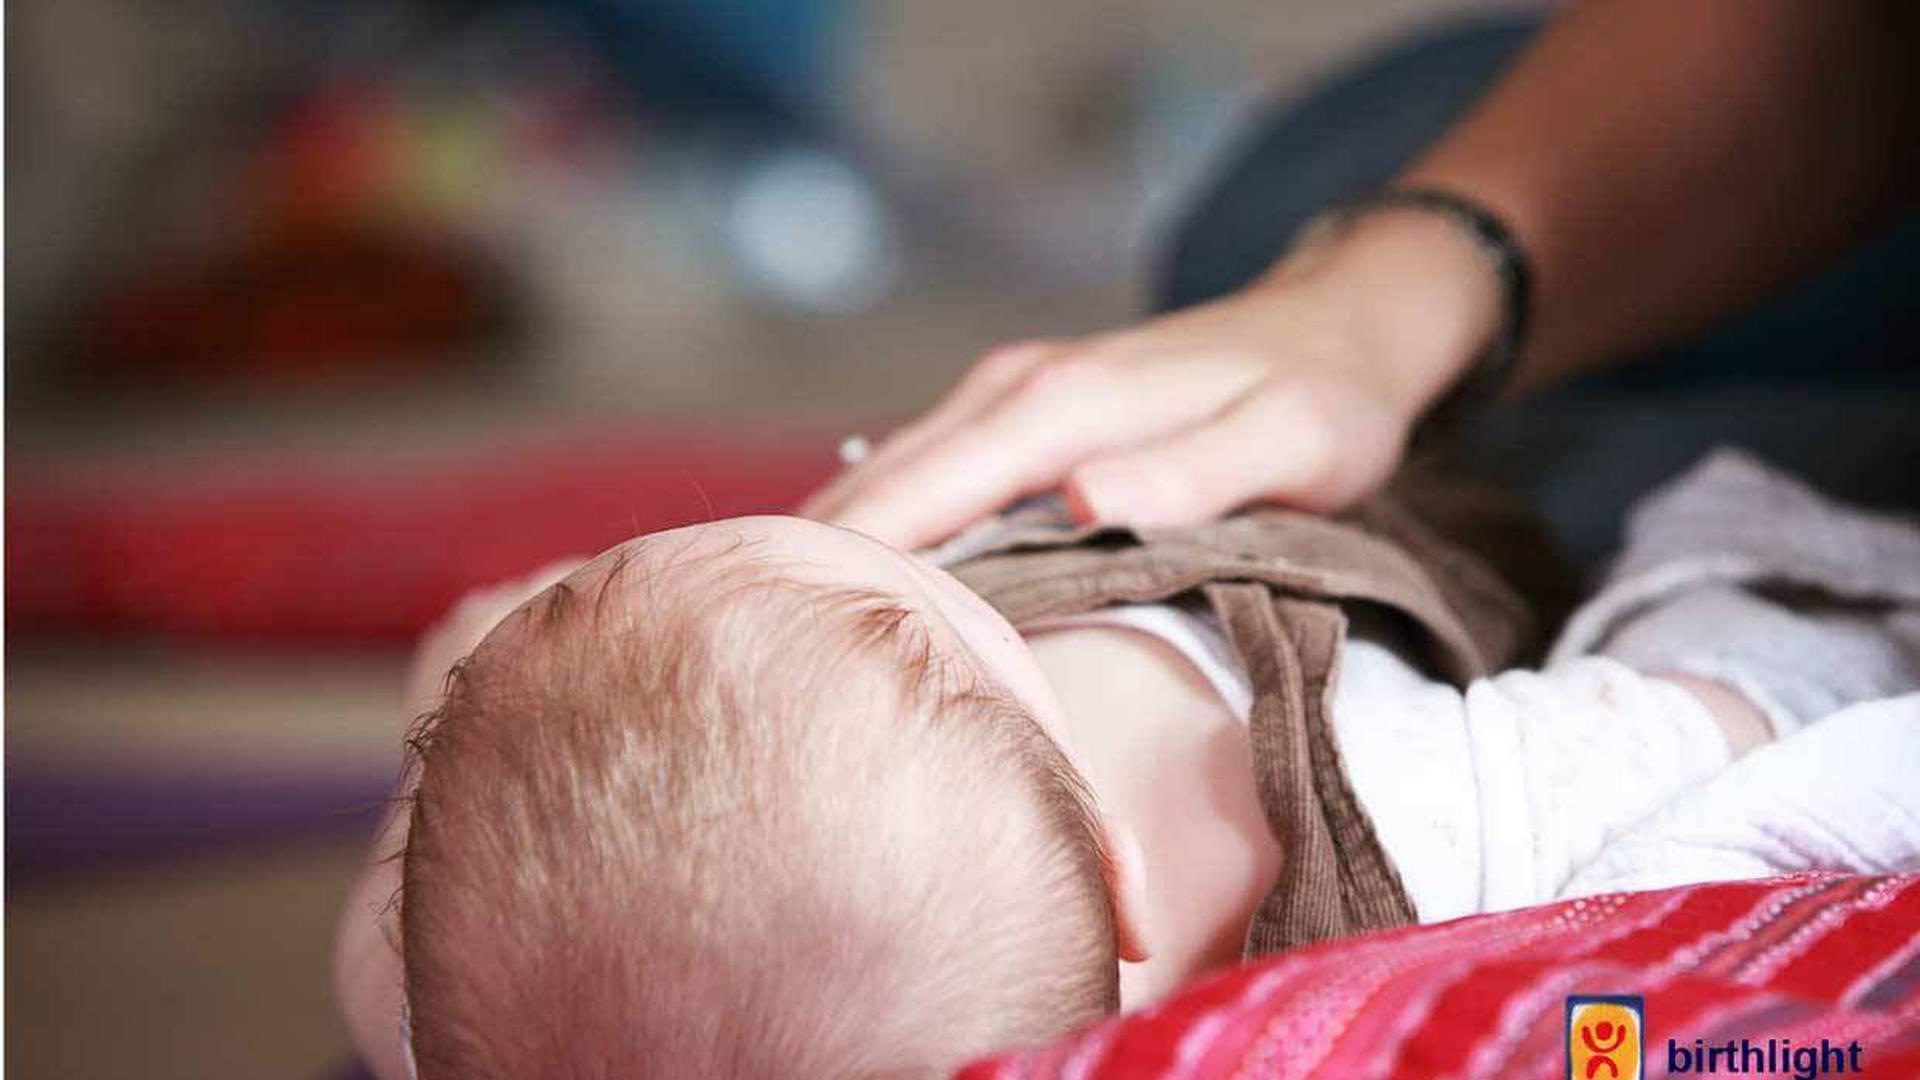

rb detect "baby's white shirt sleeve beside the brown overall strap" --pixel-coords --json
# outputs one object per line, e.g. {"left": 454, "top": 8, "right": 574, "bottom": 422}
{"left": 1334, "top": 640, "right": 1728, "bottom": 922}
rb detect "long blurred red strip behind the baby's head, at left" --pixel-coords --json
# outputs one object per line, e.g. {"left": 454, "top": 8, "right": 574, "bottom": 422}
{"left": 6, "top": 430, "right": 833, "bottom": 644}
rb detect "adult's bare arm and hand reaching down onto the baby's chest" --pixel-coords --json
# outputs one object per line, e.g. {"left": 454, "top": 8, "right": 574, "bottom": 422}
{"left": 804, "top": 0, "right": 1920, "bottom": 548}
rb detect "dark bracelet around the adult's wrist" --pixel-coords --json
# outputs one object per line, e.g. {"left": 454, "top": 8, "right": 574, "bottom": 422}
{"left": 1302, "top": 186, "right": 1534, "bottom": 444}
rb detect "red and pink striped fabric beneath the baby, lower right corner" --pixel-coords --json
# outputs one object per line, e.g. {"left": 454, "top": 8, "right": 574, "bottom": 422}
{"left": 960, "top": 874, "right": 1920, "bottom": 1080}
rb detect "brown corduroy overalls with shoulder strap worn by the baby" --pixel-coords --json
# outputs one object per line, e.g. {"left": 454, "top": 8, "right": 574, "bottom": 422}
{"left": 936, "top": 474, "right": 1567, "bottom": 955}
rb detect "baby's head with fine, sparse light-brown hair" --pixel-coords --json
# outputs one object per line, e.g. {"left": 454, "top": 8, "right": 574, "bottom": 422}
{"left": 401, "top": 519, "right": 1117, "bottom": 1080}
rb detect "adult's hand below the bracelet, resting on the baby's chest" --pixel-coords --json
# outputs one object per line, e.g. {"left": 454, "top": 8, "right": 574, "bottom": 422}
{"left": 801, "top": 209, "right": 1500, "bottom": 548}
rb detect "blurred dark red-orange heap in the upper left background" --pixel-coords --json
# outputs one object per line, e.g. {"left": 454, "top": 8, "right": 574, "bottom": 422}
{"left": 83, "top": 83, "right": 529, "bottom": 384}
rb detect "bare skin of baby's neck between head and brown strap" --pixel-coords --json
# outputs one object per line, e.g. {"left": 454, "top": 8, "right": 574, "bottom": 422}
{"left": 1027, "top": 626, "right": 1281, "bottom": 1009}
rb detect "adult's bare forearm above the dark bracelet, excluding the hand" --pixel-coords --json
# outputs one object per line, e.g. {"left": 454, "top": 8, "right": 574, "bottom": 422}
{"left": 1402, "top": 0, "right": 1920, "bottom": 384}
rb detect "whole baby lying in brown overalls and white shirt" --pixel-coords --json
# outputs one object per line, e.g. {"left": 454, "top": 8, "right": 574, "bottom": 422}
{"left": 338, "top": 447, "right": 1920, "bottom": 1078}
